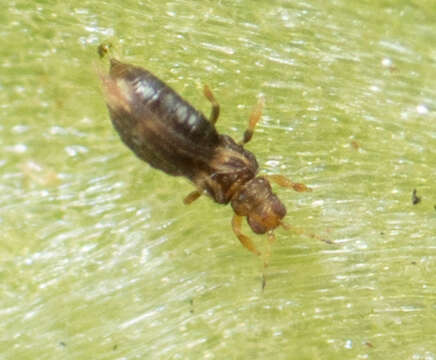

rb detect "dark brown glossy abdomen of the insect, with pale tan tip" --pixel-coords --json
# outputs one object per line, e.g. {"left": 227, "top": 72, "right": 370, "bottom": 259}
{"left": 103, "top": 59, "right": 219, "bottom": 178}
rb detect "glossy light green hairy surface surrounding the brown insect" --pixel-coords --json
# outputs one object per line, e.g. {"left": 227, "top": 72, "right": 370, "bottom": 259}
{"left": 0, "top": 0, "right": 436, "bottom": 360}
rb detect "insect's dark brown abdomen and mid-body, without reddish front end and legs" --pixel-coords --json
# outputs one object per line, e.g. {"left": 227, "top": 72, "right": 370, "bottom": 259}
{"left": 104, "top": 60, "right": 258, "bottom": 204}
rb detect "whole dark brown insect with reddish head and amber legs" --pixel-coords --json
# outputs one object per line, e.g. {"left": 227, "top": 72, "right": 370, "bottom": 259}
{"left": 99, "top": 48, "right": 311, "bottom": 255}
